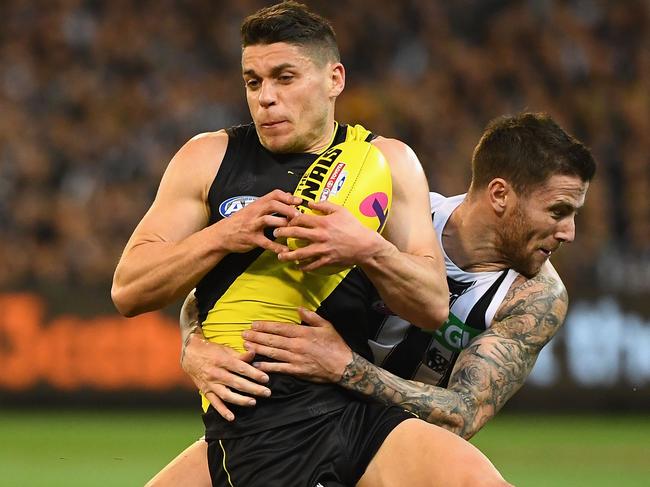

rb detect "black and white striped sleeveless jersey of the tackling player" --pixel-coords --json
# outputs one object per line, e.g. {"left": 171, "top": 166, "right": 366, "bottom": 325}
{"left": 369, "top": 193, "right": 519, "bottom": 387}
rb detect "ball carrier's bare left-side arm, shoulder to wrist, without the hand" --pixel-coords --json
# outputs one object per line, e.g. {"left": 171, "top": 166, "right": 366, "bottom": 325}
{"left": 111, "top": 132, "right": 227, "bottom": 316}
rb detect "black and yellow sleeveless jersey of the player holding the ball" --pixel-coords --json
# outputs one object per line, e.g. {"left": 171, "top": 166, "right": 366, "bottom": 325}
{"left": 195, "top": 124, "right": 374, "bottom": 439}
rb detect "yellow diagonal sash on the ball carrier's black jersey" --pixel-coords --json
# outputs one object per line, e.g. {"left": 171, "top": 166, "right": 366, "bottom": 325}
{"left": 197, "top": 125, "right": 370, "bottom": 411}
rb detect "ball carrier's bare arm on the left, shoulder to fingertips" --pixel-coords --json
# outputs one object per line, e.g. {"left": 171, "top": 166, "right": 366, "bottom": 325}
{"left": 111, "top": 132, "right": 300, "bottom": 316}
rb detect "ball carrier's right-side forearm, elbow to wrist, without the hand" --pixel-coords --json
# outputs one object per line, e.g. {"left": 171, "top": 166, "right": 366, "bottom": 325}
{"left": 361, "top": 237, "right": 449, "bottom": 329}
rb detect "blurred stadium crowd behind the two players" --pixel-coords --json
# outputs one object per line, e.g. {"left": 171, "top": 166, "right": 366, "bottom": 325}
{"left": 0, "top": 0, "right": 650, "bottom": 298}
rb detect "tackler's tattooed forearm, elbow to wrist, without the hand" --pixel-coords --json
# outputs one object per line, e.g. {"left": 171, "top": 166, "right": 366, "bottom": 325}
{"left": 339, "top": 353, "right": 476, "bottom": 437}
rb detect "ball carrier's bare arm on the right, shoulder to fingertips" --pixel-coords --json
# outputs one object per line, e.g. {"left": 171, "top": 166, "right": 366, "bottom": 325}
{"left": 276, "top": 138, "right": 449, "bottom": 329}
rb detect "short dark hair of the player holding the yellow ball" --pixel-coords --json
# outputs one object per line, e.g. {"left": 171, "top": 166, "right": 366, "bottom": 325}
{"left": 241, "top": 0, "right": 341, "bottom": 64}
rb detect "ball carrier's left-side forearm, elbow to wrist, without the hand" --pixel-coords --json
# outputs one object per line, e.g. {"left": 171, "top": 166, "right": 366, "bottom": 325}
{"left": 111, "top": 227, "right": 226, "bottom": 316}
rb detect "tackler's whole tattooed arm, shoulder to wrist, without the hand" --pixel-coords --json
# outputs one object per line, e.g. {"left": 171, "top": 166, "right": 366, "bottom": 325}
{"left": 339, "top": 264, "right": 568, "bottom": 438}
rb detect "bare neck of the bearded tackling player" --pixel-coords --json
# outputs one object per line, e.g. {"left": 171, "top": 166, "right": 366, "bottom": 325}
{"left": 442, "top": 200, "right": 509, "bottom": 272}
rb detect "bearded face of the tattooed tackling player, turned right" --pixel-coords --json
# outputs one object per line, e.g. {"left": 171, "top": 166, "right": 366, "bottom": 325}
{"left": 500, "top": 175, "right": 589, "bottom": 277}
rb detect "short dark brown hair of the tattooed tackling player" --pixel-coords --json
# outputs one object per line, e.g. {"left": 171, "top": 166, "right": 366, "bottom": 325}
{"left": 472, "top": 112, "right": 596, "bottom": 194}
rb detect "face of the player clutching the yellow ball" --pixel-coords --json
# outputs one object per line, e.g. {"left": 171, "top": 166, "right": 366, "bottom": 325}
{"left": 242, "top": 42, "right": 344, "bottom": 152}
